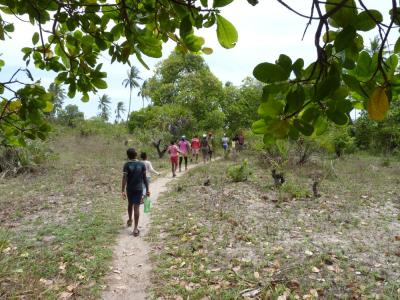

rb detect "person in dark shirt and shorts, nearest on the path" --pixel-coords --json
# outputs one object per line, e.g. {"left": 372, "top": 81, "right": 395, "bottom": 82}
{"left": 122, "top": 148, "right": 150, "bottom": 236}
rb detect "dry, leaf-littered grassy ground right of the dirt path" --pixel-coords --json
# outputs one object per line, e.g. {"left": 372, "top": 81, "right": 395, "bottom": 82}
{"left": 150, "top": 155, "right": 400, "bottom": 299}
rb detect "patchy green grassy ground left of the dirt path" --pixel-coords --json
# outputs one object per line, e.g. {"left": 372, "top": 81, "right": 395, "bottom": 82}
{"left": 0, "top": 132, "right": 163, "bottom": 299}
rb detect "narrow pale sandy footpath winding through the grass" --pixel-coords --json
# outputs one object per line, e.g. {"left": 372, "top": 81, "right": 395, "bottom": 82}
{"left": 102, "top": 164, "right": 200, "bottom": 300}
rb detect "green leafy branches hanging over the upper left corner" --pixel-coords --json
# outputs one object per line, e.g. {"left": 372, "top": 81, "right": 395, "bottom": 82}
{"left": 0, "top": 0, "right": 237, "bottom": 144}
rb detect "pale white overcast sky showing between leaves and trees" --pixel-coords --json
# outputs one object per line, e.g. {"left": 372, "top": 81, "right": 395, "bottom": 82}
{"left": 0, "top": 0, "right": 391, "bottom": 119}
